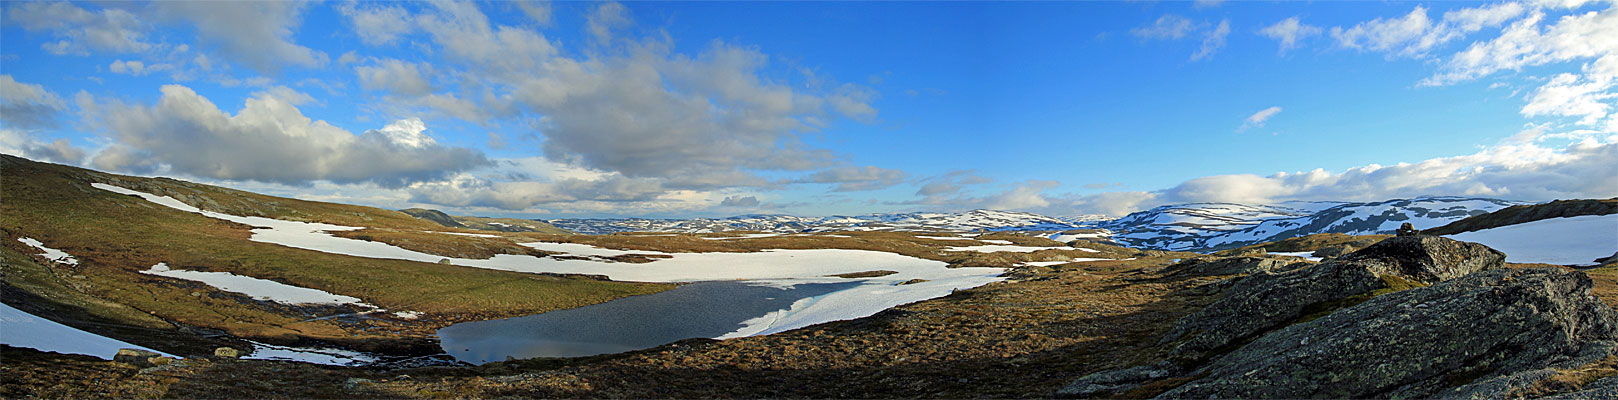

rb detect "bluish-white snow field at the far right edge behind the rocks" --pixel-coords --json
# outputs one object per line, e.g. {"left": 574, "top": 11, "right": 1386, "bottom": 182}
{"left": 1450, "top": 214, "right": 1618, "bottom": 266}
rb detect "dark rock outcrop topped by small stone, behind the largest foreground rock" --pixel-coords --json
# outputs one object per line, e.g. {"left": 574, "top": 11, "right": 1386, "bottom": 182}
{"left": 1163, "top": 236, "right": 1505, "bottom": 360}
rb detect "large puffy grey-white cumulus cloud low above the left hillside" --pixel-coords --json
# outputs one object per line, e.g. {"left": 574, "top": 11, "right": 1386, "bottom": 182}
{"left": 87, "top": 84, "right": 489, "bottom": 186}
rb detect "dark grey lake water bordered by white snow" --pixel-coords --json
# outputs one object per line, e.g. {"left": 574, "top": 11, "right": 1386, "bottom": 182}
{"left": 438, "top": 280, "right": 859, "bottom": 364}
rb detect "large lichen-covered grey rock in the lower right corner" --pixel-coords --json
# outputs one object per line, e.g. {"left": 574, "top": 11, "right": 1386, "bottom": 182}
{"left": 1160, "top": 269, "right": 1618, "bottom": 398}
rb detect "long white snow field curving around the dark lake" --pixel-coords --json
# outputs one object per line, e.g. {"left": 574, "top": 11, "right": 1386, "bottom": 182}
{"left": 92, "top": 183, "right": 1009, "bottom": 353}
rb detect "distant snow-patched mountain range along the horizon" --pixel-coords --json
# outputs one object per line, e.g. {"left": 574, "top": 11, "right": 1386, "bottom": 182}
{"left": 547, "top": 196, "right": 1527, "bottom": 251}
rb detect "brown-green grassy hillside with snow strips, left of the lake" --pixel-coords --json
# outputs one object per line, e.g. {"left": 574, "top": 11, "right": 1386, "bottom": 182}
{"left": 0, "top": 155, "right": 671, "bottom": 354}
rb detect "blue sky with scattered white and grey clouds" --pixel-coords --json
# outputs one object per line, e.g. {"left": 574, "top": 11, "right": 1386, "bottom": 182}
{"left": 0, "top": 2, "right": 1618, "bottom": 219}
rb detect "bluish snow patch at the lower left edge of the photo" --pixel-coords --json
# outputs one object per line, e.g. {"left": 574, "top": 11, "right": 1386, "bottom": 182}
{"left": 0, "top": 304, "right": 168, "bottom": 360}
